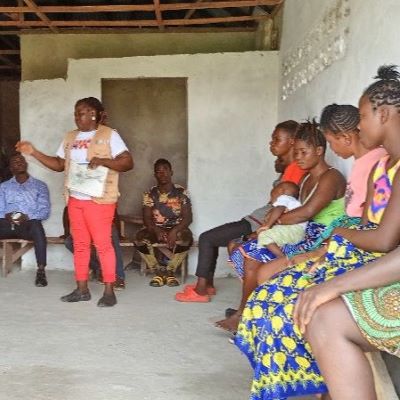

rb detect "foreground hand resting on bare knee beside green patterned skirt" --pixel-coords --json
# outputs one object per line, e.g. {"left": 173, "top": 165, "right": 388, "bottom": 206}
{"left": 293, "top": 281, "right": 340, "bottom": 334}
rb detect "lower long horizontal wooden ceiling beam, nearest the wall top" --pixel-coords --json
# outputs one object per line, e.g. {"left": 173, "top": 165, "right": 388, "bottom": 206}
{"left": 0, "top": 15, "right": 270, "bottom": 28}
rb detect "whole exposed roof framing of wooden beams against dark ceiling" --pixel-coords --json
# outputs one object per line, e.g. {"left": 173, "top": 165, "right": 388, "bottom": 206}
{"left": 0, "top": 0, "right": 285, "bottom": 79}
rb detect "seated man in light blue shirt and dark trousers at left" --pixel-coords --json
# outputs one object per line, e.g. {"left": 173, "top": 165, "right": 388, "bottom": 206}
{"left": 0, "top": 154, "right": 50, "bottom": 287}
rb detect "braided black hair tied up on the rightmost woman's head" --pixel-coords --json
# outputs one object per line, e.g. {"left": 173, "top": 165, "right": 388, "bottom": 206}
{"left": 363, "top": 65, "right": 400, "bottom": 110}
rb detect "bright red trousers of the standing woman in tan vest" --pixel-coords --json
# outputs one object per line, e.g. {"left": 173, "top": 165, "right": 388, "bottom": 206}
{"left": 68, "top": 197, "right": 115, "bottom": 283}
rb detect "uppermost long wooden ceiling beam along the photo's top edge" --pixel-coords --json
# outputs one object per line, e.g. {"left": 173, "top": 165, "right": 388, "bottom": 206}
{"left": 0, "top": 0, "right": 283, "bottom": 13}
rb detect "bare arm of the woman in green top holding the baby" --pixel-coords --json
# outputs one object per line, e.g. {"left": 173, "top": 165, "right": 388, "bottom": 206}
{"left": 280, "top": 169, "right": 346, "bottom": 225}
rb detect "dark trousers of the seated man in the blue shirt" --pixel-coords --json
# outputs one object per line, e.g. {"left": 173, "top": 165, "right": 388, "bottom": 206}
{"left": 0, "top": 218, "right": 47, "bottom": 267}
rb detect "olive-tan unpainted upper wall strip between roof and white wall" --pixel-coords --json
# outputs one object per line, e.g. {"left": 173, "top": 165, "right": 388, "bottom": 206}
{"left": 21, "top": 32, "right": 256, "bottom": 80}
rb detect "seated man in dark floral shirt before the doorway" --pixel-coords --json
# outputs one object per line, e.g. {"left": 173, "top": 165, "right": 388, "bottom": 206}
{"left": 135, "top": 158, "right": 193, "bottom": 287}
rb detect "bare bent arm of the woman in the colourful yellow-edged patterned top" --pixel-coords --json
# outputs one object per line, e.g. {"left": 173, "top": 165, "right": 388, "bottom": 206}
{"left": 334, "top": 172, "right": 400, "bottom": 253}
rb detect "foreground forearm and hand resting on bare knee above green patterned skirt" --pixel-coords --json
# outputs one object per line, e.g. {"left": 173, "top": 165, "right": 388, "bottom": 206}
{"left": 293, "top": 248, "right": 400, "bottom": 333}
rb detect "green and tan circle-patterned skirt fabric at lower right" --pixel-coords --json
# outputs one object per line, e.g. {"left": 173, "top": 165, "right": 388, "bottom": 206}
{"left": 343, "top": 282, "right": 400, "bottom": 356}
